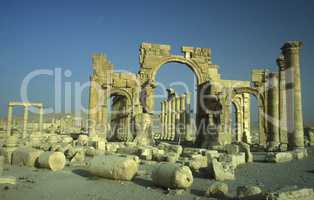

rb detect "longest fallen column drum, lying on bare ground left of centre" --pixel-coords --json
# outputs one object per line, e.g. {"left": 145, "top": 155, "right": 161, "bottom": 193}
{"left": 87, "top": 155, "right": 138, "bottom": 181}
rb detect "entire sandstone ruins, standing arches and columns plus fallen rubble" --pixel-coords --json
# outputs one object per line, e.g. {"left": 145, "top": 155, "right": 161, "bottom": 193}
{"left": 0, "top": 41, "right": 314, "bottom": 200}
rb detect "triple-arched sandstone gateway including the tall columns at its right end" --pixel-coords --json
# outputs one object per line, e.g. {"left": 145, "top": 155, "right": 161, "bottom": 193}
{"left": 89, "top": 41, "right": 304, "bottom": 148}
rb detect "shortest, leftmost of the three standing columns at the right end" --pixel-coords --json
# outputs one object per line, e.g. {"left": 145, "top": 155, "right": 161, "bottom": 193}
{"left": 269, "top": 73, "right": 280, "bottom": 146}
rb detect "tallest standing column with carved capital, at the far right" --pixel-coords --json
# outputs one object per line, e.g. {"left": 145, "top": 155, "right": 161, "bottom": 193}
{"left": 281, "top": 41, "right": 304, "bottom": 148}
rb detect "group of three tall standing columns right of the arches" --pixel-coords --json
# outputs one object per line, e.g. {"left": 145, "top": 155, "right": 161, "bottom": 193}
{"left": 268, "top": 41, "right": 304, "bottom": 149}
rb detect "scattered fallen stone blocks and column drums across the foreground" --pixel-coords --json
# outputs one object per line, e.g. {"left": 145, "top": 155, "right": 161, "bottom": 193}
{"left": 0, "top": 134, "right": 314, "bottom": 200}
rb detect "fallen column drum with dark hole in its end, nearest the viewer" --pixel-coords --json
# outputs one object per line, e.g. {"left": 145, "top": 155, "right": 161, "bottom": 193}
{"left": 152, "top": 163, "right": 193, "bottom": 189}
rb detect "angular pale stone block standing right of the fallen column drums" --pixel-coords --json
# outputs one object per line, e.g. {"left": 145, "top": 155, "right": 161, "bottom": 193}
{"left": 210, "top": 159, "right": 235, "bottom": 181}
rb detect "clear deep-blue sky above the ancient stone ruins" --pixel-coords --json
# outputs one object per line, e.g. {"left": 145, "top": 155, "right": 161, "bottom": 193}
{"left": 0, "top": 0, "right": 314, "bottom": 122}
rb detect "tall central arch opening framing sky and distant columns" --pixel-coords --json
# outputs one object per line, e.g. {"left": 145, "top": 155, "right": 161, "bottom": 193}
{"left": 153, "top": 61, "right": 198, "bottom": 143}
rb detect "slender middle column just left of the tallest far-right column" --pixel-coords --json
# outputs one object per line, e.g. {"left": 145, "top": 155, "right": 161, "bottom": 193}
{"left": 276, "top": 55, "right": 288, "bottom": 144}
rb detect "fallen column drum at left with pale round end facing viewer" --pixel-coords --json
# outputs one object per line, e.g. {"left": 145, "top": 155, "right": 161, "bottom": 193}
{"left": 38, "top": 151, "right": 66, "bottom": 171}
